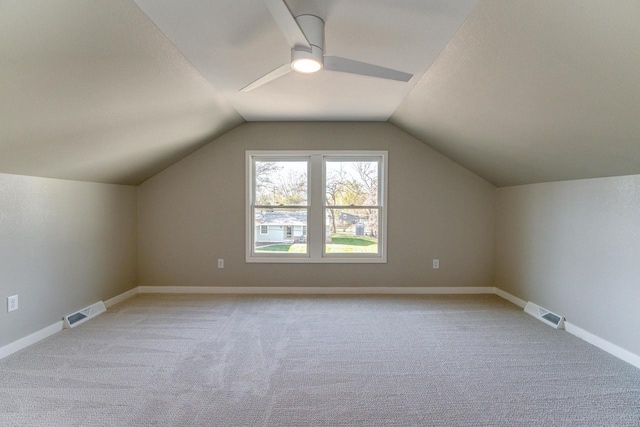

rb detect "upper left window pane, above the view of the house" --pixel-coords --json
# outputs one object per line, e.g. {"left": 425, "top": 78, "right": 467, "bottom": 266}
{"left": 255, "top": 160, "right": 307, "bottom": 206}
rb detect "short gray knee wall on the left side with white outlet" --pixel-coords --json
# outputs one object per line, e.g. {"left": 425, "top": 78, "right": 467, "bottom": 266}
{"left": 0, "top": 174, "right": 137, "bottom": 347}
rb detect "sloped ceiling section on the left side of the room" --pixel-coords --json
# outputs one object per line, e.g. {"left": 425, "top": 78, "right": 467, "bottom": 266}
{"left": 0, "top": 0, "right": 243, "bottom": 185}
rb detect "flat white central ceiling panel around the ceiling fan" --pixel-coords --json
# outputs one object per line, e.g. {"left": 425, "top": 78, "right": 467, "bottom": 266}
{"left": 135, "top": 0, "right": 478, "bottom": 121}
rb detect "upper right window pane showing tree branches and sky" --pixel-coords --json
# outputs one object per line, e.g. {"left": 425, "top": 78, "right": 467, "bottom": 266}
{"left": 325, "top": 160, "right": 380, "bottom": 206}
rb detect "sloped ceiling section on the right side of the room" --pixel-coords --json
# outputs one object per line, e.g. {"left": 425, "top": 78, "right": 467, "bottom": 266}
{"left": 390, "top": 0, "right": 640, "bottom": 186}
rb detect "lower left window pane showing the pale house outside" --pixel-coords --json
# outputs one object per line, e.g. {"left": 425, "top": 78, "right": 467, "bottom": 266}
{"left": 253, "top": 209, "right": 307, "bottom": 255}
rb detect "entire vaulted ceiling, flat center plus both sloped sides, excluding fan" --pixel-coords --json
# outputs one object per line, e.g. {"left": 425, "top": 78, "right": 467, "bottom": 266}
{"left": 0, "top": 0, "right": 640, "bottom": 186}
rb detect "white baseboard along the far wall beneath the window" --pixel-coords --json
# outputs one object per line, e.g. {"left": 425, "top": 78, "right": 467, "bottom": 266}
{"left": 138, "top": 286, "right": 494, "bottom": 295}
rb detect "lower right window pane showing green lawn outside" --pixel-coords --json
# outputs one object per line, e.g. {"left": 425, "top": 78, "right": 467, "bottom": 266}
{"left": 325, "top": 208, "right": 379, "bottom": 254}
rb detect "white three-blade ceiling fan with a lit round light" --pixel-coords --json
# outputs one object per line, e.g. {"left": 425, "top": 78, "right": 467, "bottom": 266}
{"left": 240, "top": 0, "right": 413, "bottom": 92}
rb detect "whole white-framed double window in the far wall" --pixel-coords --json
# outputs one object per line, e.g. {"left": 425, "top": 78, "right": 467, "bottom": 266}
{"left": 246, "top": 151, "right": 387, "bottom": 263}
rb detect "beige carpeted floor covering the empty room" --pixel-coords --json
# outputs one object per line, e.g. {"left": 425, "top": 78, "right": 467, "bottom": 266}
{"left": 0, "top": 295, "right": 640, "bottom": 426}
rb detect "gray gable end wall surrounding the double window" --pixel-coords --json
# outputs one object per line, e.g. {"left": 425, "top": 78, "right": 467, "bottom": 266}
{"left": 138, "top": 122, "right": 495, "bottom": 286}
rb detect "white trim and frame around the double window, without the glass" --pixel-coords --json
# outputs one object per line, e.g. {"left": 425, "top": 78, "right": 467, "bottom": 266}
{"left": 245, "top": 150, "right": 389, "bottom": 264}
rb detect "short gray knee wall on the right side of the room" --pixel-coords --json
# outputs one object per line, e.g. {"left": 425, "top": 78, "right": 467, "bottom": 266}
{"left": 496, "top": 175, "right": 640, "bottom": 354}
